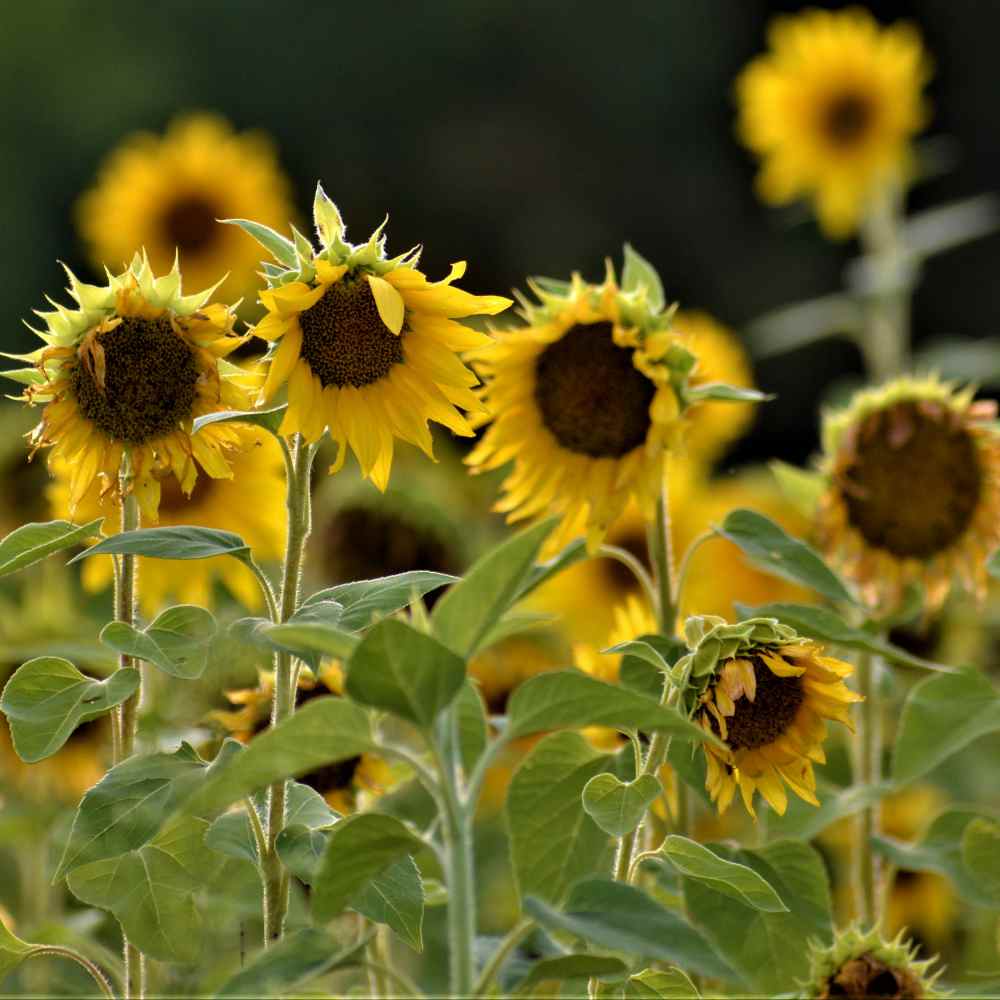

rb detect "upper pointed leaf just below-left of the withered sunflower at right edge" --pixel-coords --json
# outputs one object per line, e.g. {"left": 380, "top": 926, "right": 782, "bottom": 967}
{"left": 715, "top": 508, "right": 857, "bottom": 604}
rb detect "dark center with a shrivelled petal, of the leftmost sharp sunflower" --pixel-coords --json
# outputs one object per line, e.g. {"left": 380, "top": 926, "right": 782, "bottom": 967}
{"left": 70, "top": 316, "right": 199, "bottom": 444}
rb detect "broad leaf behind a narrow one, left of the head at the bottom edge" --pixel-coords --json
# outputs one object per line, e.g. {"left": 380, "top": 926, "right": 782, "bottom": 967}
{"left": 678, "top": 840, "right": 832, "bottom": 996}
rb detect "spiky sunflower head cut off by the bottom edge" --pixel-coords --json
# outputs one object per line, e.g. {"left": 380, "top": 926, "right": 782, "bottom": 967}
{"left": 805, "top": 926, "right": 948, "bottom": 1000}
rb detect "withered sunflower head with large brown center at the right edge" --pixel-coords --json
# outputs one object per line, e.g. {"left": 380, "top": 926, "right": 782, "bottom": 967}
{"left": 818, "top": 377, "right": 1000, "bottom": 611}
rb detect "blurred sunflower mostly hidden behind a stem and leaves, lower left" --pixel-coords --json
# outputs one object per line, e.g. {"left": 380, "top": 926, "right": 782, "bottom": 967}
{"left": 208, "top": 661, "right": 393, "bottom": 816}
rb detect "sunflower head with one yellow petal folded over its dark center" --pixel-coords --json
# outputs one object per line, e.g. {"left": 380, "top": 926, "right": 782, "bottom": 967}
{"left": 234, "top": 185, "right": 511, "bottom": 490}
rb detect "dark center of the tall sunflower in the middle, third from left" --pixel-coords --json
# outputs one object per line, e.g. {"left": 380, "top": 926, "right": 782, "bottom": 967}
{"left": 535, "top": 323, "right": 656, "bottom": 458}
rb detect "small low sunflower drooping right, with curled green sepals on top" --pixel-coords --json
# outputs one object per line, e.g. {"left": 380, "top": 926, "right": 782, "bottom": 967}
{"left": 674, "top": 615, "right": 861, "bottom": 817}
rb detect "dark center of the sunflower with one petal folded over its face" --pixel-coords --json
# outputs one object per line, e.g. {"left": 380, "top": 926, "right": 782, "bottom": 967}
{"left": 299, "top": 274, "right": 406, "bottom": 389}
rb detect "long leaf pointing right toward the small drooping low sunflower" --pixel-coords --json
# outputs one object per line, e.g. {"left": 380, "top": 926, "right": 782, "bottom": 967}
{"left": 507, "top": 670, "right": 713, "bottom": 742}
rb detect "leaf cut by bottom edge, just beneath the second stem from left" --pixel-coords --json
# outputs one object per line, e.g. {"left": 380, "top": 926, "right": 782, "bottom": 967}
{"left": 215, "top": 927, "right": 358, "bottom": 1000}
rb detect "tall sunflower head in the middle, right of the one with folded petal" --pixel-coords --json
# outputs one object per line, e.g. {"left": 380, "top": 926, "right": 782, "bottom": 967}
{"left": 466, "top": 261, "right": 696, "bottom": 552}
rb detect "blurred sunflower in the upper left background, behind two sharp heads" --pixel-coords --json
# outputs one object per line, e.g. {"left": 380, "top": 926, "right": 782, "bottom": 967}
{"left": 76, "top": 114, "right": 292, "bottom": 298}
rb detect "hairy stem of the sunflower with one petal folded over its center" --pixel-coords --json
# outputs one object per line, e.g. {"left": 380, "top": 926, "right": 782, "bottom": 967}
{"left": 262, "top": 434, "right": 315, "bottom": 948}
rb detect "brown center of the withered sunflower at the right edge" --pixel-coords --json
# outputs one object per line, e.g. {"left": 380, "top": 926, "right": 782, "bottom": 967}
{"left": 843, "top": 403, "right": 982, "bottom": 559}
